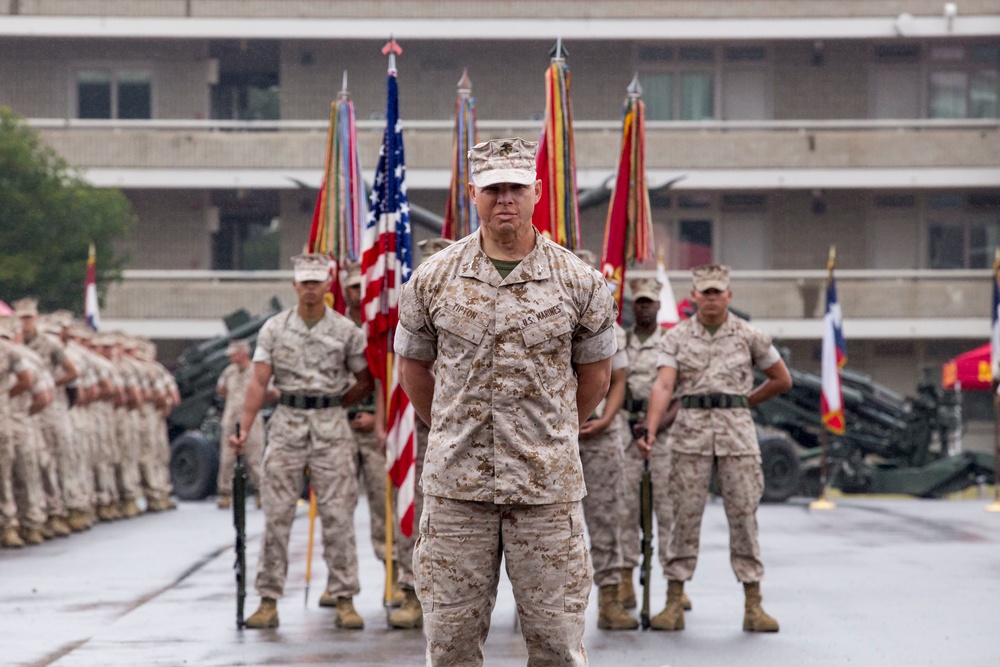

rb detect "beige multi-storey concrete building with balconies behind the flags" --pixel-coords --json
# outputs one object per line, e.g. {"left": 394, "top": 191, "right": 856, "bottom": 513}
{"left": 0, "top": 0, "right": 1000, "bottom": 428}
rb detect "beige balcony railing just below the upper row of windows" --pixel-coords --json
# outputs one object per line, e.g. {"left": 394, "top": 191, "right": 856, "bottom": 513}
{"left": 30, "top": 119, "right": 1000, "bottom": 175}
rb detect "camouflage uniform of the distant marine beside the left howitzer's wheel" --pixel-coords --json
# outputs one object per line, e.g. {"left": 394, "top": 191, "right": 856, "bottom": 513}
{"left": 216, "top": 360, "right": 264, "bottom": 496}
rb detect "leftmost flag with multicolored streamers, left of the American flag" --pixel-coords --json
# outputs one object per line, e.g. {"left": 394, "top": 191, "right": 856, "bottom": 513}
{"left": 308, "top": 72, "right": 368, "bottom": 313}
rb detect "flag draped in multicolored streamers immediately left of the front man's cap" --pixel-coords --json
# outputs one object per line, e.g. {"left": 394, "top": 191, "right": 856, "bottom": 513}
{"left": 441, "top": 70, "right": 479, "bottom": 241}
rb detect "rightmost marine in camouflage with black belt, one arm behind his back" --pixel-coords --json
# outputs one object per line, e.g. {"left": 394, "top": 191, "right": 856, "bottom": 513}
{"left": 639, "top": 264, "right": 792, "bottom": 632}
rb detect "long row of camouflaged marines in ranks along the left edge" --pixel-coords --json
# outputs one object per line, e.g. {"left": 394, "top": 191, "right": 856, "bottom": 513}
{"left": 0, "top": 298, "right": 179, "bottom": 548}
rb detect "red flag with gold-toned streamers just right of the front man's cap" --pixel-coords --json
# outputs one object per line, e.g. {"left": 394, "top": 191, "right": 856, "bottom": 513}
{"left": 531, "top": 39, "right": 580, "bottom": 250}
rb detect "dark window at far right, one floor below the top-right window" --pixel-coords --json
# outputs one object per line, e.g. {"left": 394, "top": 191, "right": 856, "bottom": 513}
{"left": 927, "top": 193, "right": 1000, "bottom": 269}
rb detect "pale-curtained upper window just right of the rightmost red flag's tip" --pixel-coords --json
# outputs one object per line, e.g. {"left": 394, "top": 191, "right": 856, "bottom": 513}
{"left": 638, "top": 46, "right": 716, "bottom": 120}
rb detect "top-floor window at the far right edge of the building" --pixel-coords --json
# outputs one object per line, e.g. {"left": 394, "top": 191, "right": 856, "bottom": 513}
{"left": 928, "top": 44, "right": 1000, "bottom": 118}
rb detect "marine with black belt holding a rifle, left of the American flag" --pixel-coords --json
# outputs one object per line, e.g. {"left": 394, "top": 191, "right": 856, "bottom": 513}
{"left": 229, "top": 253, "right": 374, "bottom": 629}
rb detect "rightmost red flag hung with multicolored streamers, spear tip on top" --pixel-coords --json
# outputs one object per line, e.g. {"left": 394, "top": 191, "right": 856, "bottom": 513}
{"left": 601, "top": 74, "right": 656, "bottom": 322}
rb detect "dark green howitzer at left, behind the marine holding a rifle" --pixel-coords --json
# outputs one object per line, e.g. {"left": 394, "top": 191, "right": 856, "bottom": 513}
{"left": 167, "top": 298, "right": 281, "bottom": 500}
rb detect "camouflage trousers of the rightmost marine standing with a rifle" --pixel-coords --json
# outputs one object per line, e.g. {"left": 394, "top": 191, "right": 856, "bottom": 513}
{"left": 654, "top": 451, "right": 764, "bottom": 583}
